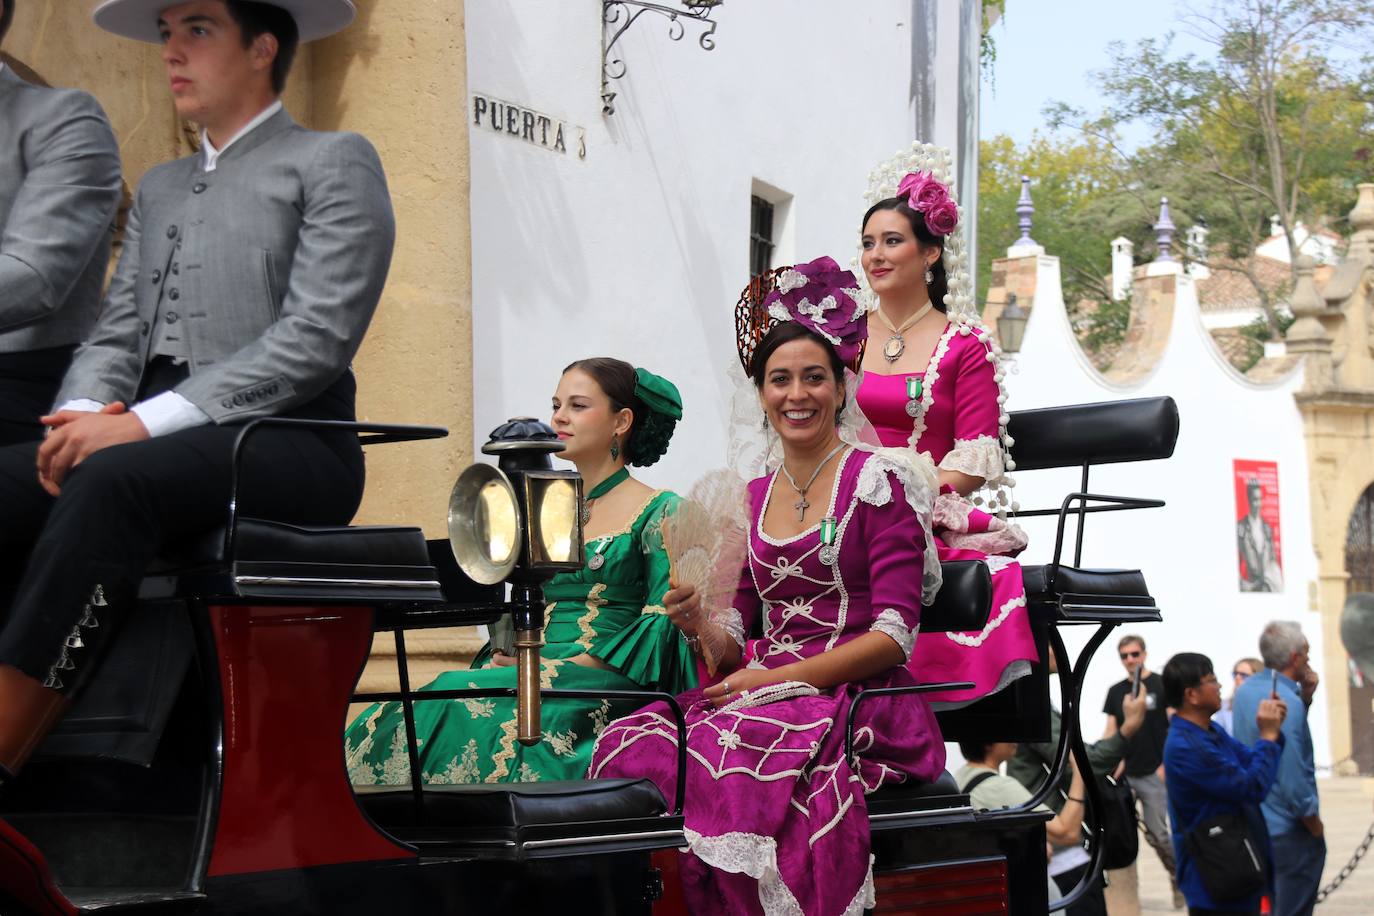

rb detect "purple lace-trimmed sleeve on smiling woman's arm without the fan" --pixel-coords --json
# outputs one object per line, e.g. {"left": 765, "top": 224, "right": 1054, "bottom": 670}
{"left": 859, "top": 455, "right": 940, "bottom": 658}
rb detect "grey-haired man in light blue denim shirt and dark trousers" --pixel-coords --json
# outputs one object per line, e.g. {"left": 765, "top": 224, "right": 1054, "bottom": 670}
{"left": 1232, "top": 621, "right": 1326, "bottom": 916}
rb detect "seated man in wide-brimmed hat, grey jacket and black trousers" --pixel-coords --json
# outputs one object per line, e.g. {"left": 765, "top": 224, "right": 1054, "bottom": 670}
{"left": 0, "top": 0, "right": 396, "bottom": 780}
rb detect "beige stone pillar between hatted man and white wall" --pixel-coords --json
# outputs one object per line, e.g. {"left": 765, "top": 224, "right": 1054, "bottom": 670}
{"left": 311, "top": 0, "right": 481, "bottom": 689}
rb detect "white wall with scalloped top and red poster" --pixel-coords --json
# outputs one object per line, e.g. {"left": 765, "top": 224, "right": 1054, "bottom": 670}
{"left": 1007, "top": 255, "right": 1324, "bottom": 764}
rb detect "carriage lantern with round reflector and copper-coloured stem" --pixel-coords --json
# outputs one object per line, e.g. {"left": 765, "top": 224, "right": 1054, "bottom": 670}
{"left": 448, "top": 417, "right": 583, "bottom": 746}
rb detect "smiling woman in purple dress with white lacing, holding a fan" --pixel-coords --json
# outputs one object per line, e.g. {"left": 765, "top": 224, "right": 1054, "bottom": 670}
{"left": 591, "top": 258, "right": 945, "bottom": 916}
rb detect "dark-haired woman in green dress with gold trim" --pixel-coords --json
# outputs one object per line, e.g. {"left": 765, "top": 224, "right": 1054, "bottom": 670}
{"left": 346, "top": 358, "right": 697, "bottom": 784}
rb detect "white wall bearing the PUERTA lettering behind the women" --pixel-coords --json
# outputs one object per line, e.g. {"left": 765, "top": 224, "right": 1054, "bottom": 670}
{"left": 467, "top": 0, "right": 958, "bottom": 488}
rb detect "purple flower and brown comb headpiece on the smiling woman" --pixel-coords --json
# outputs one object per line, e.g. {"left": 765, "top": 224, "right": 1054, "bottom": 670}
{"left": 735, "top": 257, "right": 868, "bottom": 374}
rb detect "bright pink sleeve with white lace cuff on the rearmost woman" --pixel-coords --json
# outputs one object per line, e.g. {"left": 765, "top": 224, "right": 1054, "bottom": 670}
{"left": 940, "top": 331, "right": 1003, "bottom": 482}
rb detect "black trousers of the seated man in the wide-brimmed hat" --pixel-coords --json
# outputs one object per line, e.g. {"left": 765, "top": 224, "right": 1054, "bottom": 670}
{"left": 0, "top": 369, "right": 364, "bottom": 695}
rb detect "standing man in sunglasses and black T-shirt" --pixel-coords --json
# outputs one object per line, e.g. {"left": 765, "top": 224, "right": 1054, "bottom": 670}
{"left": 1102, "top": 634, "right": 1183, "bottom": 906}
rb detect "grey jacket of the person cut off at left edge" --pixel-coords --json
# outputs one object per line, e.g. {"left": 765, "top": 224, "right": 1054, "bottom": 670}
{"left": 0, "top": 67, "right": 121, "bottom": 353}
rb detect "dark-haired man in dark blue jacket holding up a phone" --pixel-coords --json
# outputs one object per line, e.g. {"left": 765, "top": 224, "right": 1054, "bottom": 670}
{"left": 1164, "top": 652, "right": 1286, "bottom": 916}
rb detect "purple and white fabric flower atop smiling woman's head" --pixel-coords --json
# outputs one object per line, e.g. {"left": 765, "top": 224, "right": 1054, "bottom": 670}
{"left": 764, "top": 257, "right": 868, "bottom": 364}
